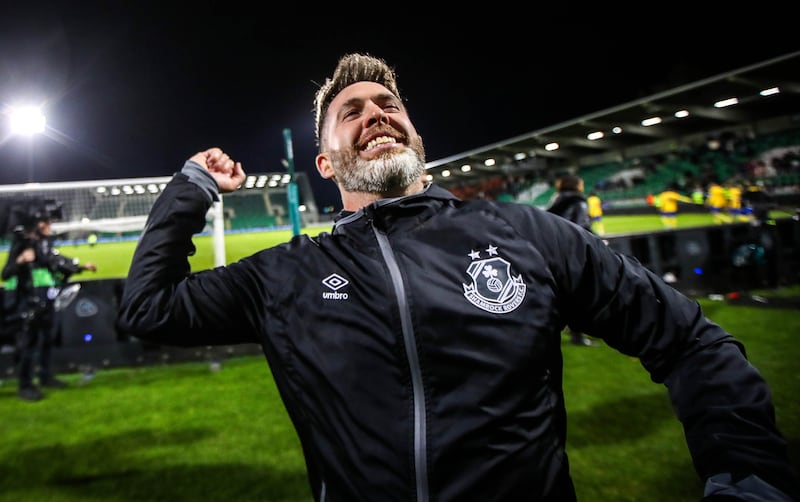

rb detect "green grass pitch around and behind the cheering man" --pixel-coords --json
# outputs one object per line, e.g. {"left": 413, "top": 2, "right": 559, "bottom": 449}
{"left": 0, "top": 210, "right": 800, "bottom": 502}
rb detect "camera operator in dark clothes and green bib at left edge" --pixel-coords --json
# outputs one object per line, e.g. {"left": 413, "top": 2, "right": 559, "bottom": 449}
{"left": 2, "top": 211, "right": 97, "bottom": 401}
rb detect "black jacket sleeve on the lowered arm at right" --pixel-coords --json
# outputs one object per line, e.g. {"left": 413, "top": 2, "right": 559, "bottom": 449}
{"left": 538, "top": 207, "right": 798, "bottom": 500}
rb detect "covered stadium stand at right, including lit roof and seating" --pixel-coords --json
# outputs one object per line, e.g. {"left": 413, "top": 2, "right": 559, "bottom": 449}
{"left": 427, "top": 51, "right": 800, "bottom": 212}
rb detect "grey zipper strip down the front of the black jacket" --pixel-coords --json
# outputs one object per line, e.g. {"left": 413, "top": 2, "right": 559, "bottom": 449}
{"left": 370, "top": 226, "right": 428, "bottom": 502}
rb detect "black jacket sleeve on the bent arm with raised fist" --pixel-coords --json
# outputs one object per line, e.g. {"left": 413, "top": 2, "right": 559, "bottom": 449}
{"left": 117, "top": 172, "right": 263, "bottom": 346}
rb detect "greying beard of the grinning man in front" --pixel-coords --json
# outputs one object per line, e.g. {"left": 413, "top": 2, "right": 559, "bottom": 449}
{"left": 331, "top": 138, "right": 425, "bottom": 194}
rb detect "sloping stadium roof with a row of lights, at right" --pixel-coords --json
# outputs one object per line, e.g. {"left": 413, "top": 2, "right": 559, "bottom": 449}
{"left": 426, "top": 51, "right": 800, "bottom": 186}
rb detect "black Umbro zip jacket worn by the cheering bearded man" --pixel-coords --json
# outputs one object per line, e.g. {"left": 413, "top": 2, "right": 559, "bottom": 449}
{"left": 118, "top": 173, "right": 791, "bottom": 502}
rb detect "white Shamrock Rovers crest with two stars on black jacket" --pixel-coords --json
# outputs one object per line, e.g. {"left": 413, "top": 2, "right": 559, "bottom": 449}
{"left": 462, "top": 246, "right": 526, "bottom": 314}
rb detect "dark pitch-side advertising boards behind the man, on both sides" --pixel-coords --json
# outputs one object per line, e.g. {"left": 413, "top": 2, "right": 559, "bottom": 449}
{"left": 0, "top": 218, "right": 800, "bottom": 378}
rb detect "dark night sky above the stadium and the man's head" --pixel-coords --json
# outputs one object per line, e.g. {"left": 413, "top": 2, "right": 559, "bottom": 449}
{"left": 0, "top": 5, "right": 800, "bottom": 208}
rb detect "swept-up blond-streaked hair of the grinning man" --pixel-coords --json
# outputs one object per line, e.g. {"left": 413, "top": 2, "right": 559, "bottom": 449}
{"left": 314, "top": 53, "right": 400, "bottom": 149}
